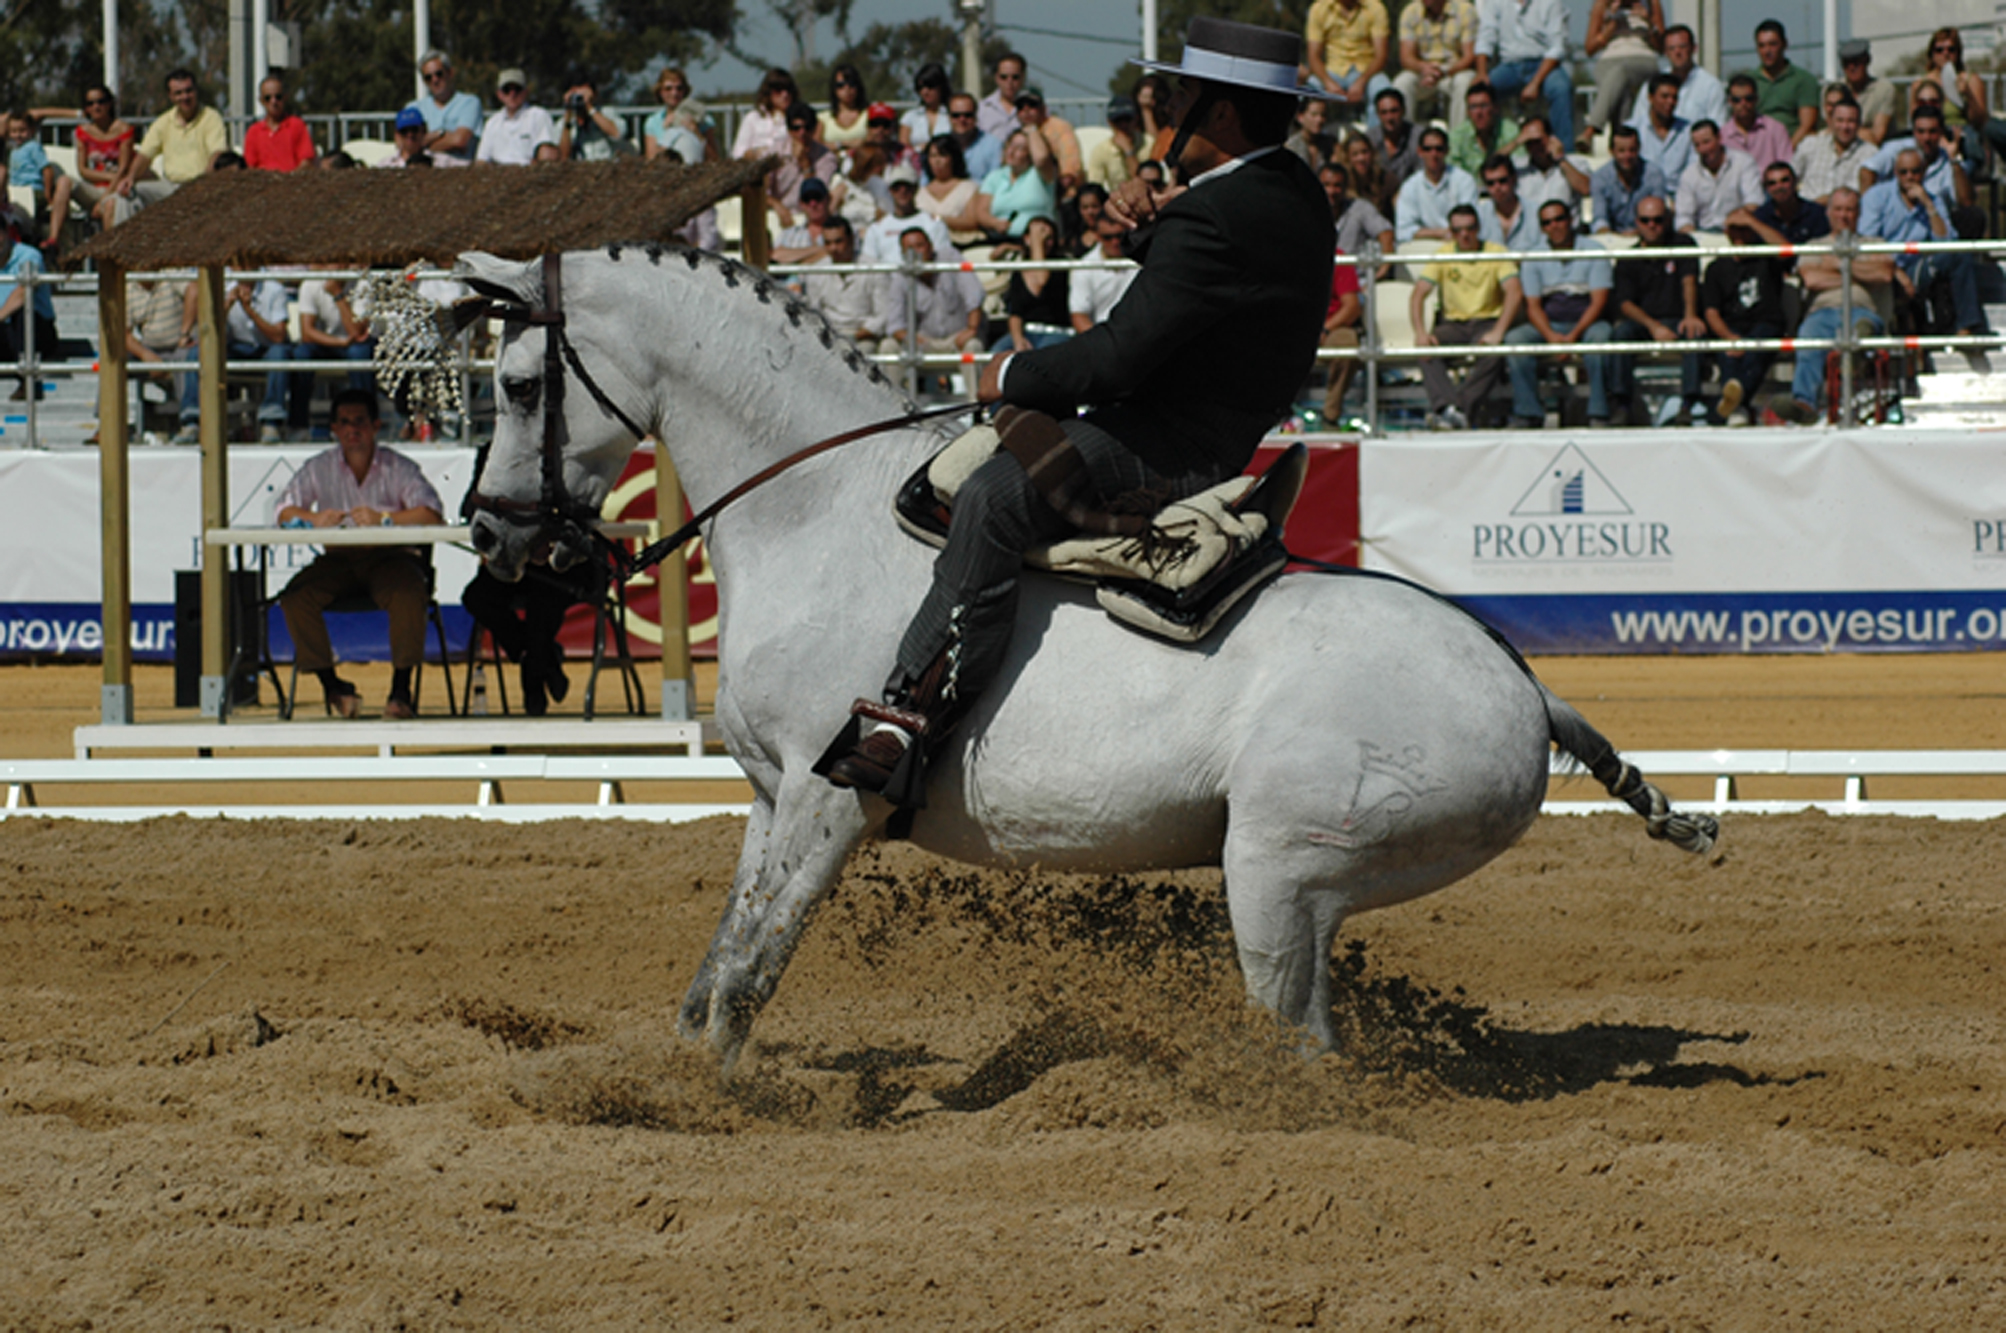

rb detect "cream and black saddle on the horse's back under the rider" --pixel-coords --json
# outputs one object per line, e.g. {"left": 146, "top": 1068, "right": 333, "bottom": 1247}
{"left": 893, "top": 423, "right": 1310, "bottom": 643}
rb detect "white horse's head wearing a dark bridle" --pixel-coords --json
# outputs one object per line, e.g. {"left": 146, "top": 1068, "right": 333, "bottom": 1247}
{"left": 453, "top": 253, "right": 648, "bottom": 581}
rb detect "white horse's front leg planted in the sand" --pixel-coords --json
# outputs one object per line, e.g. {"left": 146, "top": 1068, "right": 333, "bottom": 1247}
{"left": 682, "top": 768, "right": 869, "bottom": 1070}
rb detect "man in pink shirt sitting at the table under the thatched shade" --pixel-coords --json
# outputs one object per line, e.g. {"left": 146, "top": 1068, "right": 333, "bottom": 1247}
{"left": 277, "top": 389, "right": 441, "bottom": 718}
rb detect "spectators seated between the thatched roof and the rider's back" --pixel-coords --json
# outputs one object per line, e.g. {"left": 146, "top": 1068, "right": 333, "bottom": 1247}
{"left": 774, "top": 52, "right": 1169, "bottom": 374}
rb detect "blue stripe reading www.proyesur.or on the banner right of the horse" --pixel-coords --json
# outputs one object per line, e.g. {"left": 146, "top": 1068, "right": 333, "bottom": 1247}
{"left": 1454, "top": 591, "right": 2006, "bottom": 653}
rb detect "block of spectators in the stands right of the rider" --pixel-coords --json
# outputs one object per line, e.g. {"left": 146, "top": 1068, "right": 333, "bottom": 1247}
{"left": 1340, "top": 14, "right": 2006, "bottom": 429}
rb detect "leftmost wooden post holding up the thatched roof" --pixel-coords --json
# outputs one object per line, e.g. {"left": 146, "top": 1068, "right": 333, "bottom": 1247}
{"left": 98, "top": 261, "right": 132, "bottom": 726}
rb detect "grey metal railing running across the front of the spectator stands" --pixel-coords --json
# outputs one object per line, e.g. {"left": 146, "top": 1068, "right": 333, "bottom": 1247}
{"left": 0, "top": 237, "right": 2006, "bottom": 447}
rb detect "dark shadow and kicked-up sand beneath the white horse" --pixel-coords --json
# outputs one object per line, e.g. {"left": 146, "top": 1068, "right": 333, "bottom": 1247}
{"left": 774, "top": 876, "right": 1817, "bottom": 1127}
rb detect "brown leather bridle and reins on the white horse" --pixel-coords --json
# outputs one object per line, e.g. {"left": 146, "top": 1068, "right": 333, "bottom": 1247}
{"left": 463, "top": 255, "right": 977, "bottom": 577}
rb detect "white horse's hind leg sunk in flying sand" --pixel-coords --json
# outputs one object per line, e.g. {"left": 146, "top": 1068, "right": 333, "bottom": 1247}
{"left": 1224, "top": 822, "right": 1350, "bottom": 1050}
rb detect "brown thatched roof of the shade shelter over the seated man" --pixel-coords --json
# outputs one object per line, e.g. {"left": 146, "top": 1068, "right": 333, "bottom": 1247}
{"left": 74, "top": 160, "right": 768, "bottom": 273}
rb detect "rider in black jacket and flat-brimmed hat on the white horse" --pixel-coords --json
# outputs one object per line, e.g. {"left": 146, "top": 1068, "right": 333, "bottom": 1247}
{"left": 816, "top": 18, "right": 1332, "bottom": 806}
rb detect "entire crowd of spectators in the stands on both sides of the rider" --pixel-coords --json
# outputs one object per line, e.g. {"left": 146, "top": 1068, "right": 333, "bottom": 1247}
{"left": 0, "top": 19, "right": 2006, "bottom": 437}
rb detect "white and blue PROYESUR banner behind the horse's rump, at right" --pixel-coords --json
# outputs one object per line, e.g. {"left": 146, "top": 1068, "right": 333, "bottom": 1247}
{"left": 1360, "top": 431, "right": 2006, "bottom": 653}
